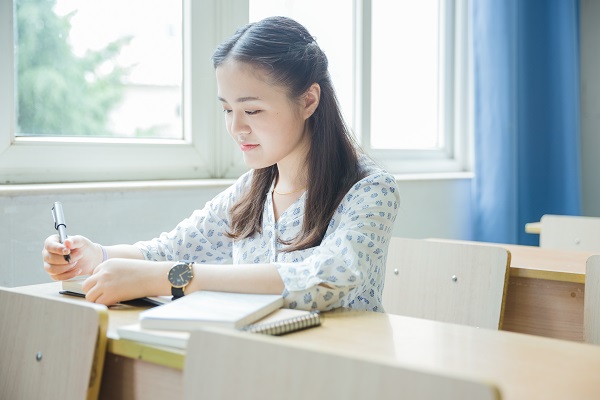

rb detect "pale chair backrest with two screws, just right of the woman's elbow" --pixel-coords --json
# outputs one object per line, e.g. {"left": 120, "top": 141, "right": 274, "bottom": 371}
{"left": 383, "top": 237, "right": 510, "bottom": 329}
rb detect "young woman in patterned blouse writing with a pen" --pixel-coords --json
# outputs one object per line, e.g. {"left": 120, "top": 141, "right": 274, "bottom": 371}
{"left": 43, "top": 17, "right": 399, "bottom": 311}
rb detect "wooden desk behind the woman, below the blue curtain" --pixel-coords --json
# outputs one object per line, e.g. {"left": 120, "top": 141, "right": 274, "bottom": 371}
{"left": 434, "top": 239, "right": 595, "bottom": 342}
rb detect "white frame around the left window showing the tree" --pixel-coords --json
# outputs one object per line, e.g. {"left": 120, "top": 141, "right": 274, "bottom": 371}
{"left": 0, "top": 0, "right": 248, "bottom": 184}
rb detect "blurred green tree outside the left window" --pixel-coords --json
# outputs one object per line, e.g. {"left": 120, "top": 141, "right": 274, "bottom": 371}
{"left": 16, "top": 0, "right": 131, "bottom": 136}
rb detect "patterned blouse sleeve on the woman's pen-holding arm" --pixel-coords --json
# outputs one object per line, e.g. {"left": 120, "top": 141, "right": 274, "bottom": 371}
{"left": 134, "top": 173, "right": 251, "bottom": 264}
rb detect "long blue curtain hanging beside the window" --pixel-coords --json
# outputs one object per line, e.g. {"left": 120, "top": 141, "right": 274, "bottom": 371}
{"left": 470, "top": 0, "right": 581, "bottom": 245}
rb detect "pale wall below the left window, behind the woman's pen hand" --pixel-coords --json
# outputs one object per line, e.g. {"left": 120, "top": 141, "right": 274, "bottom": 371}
{"left": 0, "top": 187, "right": 225, "bottom": 286}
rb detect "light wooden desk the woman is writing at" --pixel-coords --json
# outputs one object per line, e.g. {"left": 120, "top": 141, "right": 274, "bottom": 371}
{"left": 12, "top": 284, "right": 600, "bottom": 400}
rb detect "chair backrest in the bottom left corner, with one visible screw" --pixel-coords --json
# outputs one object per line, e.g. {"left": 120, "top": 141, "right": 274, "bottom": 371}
{"left": 0, "top": 288, "right": 108, "bottom": 400}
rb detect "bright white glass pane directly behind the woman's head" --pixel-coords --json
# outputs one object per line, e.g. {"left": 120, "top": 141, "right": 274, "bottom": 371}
{"left": 250, "top": 0, "right": 354, "bottom": 126}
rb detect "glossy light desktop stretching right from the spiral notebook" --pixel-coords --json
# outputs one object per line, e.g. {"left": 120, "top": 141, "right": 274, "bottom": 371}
{"left": 286, "top": 313, "right": 600, "bottom": 399}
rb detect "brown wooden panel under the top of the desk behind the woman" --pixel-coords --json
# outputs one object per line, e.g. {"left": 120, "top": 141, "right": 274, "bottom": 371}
{"left": 502, "top": 277, "right": 585, "bottom": 342}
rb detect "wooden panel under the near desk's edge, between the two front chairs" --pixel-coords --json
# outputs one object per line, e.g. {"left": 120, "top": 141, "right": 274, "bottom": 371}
{"left": 99, "top": 353, "right": 183, "bottom": 400}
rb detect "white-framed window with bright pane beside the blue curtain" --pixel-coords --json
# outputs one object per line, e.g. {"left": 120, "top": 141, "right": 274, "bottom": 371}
{"left": 358, "top": 0, "right": 470, "bottom": 173}
